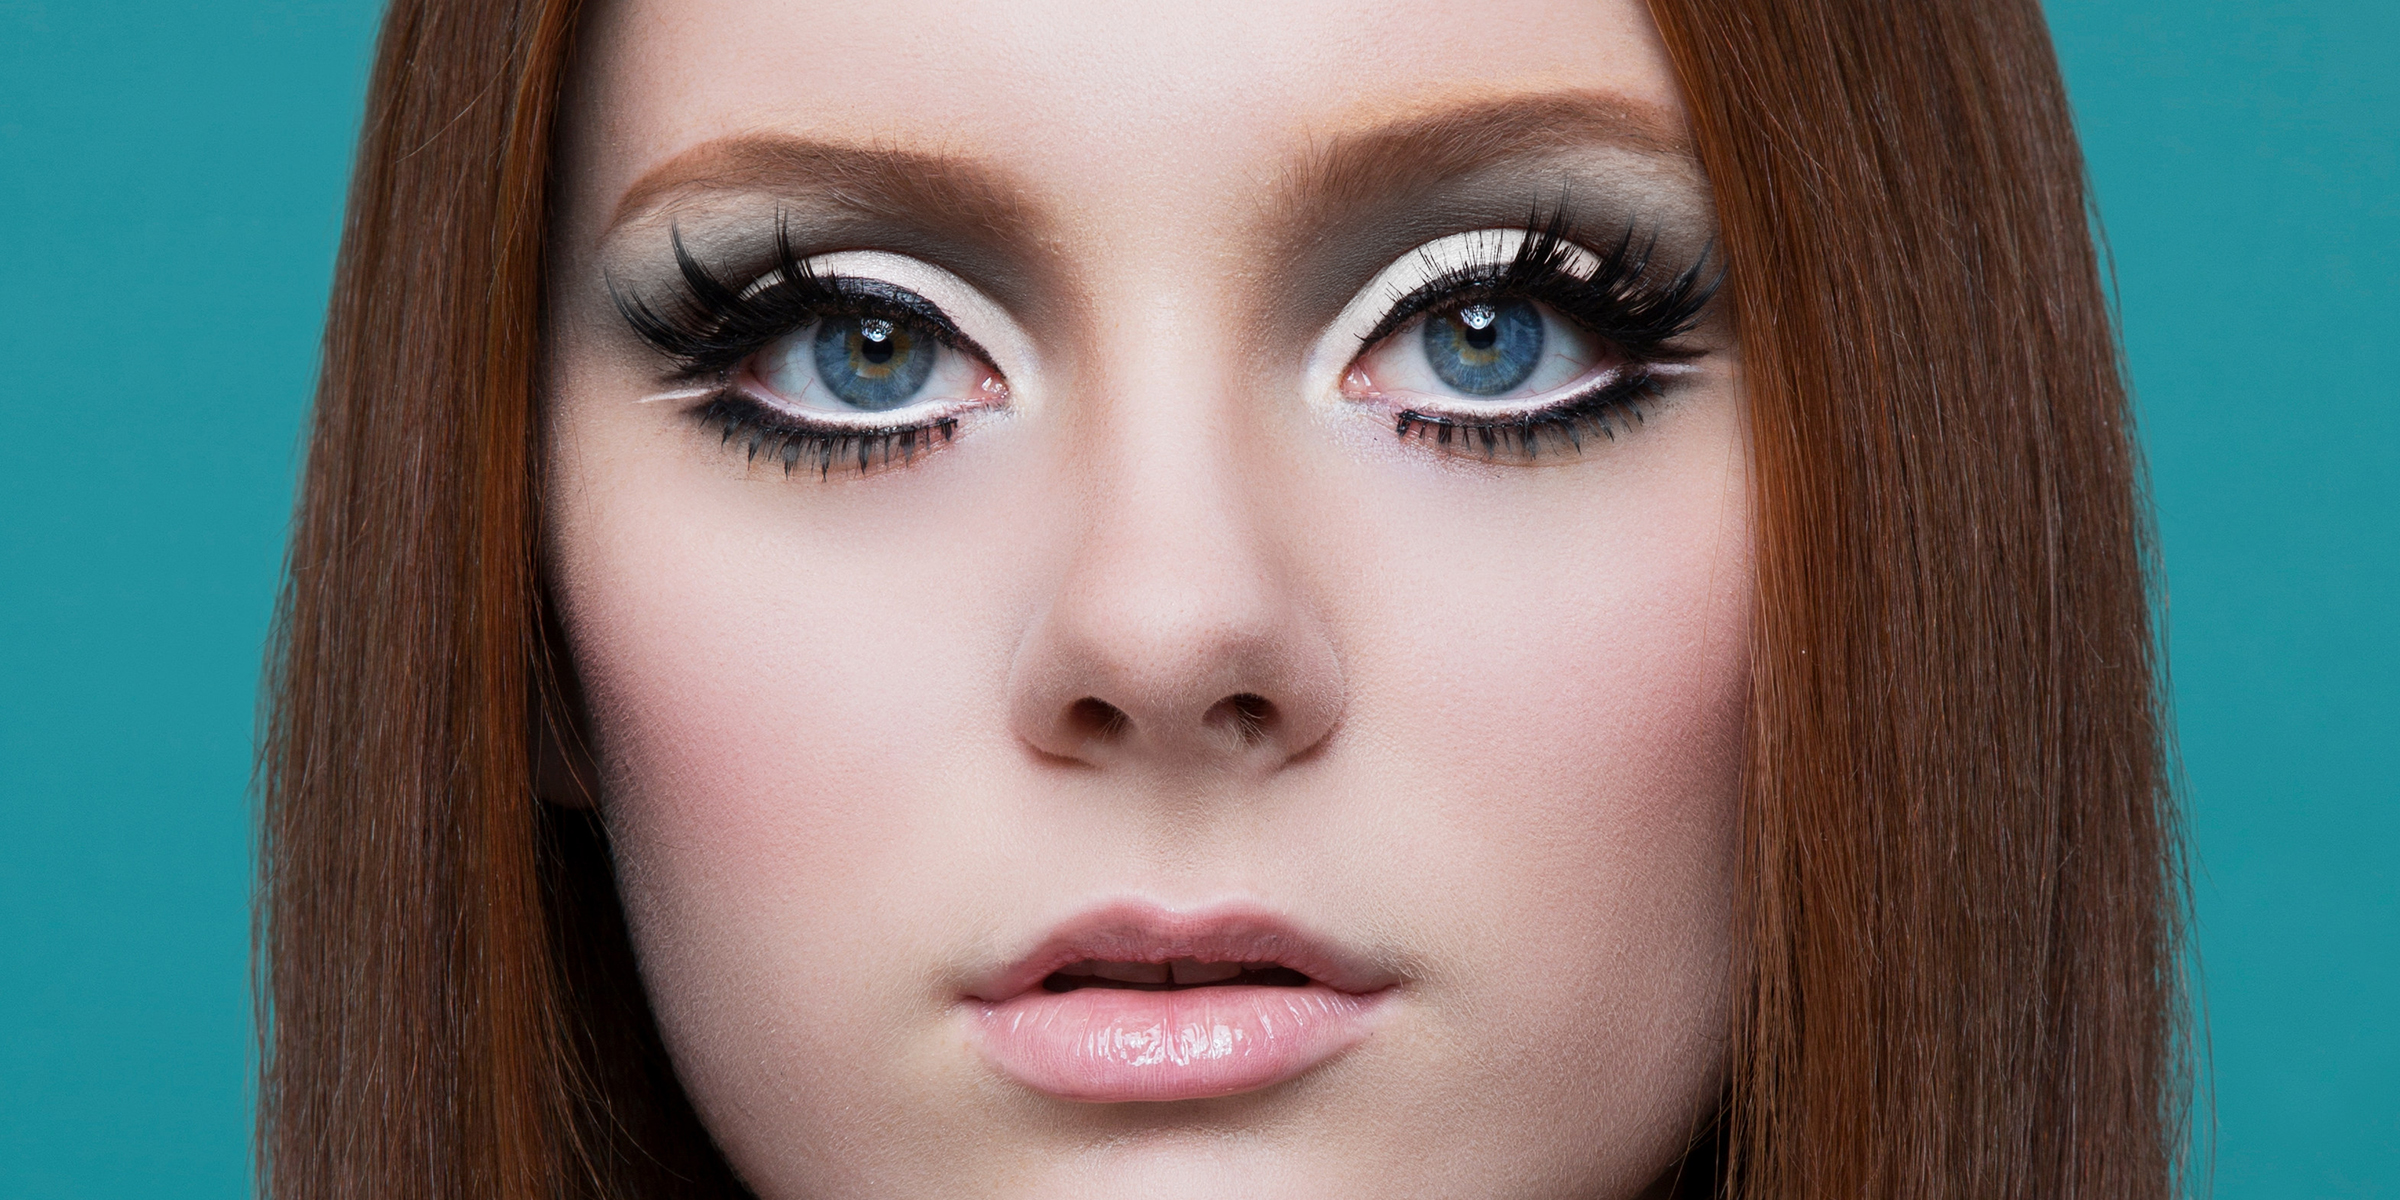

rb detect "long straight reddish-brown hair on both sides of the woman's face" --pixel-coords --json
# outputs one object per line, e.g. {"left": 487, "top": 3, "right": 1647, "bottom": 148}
{"left": 259, "top": 0, "right": 2189, "bottom": 1200}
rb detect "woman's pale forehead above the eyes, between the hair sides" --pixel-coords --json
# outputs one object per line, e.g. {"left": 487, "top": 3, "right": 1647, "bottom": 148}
{"left": 566, "top": 0, "right": 1682, "bottom": 235}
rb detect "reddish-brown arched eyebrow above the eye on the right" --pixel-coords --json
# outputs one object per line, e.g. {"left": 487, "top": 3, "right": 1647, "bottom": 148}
{"left": 1270, "top": 91, "right": 1699, "bottom": 230}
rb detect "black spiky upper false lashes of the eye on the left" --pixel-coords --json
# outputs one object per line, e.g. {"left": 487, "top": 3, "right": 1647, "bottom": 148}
{"left": 607, "top": 218, "right": 991, "bottom": 382}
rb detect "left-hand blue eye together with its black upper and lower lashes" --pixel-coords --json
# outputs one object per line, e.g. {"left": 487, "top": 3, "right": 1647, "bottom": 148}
{"left": 610, "top": 223, "right": 1008, "bottom": 478}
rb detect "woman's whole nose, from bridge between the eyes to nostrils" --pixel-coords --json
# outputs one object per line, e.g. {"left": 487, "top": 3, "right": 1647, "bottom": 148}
{"left": 1010, "top": 319, "right": 1342, "bottom": 766}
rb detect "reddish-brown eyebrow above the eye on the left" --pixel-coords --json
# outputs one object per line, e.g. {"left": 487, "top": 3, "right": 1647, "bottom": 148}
{"left": 602, "top": 134, "right": 1039, "bottom": 242}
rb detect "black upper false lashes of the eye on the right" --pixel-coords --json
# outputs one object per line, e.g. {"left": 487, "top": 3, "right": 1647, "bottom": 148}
{"left": 1358, "top": 209, "right": 1726, "bottom": 362}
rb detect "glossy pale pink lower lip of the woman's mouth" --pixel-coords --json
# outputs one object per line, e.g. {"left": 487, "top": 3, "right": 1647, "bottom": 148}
{"left": 974, "top": 984, "right": 1380, "bottom": 1104}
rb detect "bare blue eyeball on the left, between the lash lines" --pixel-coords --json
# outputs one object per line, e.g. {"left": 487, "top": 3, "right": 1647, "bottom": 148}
{"left": 751, "top": 314, "right": 986, "bottom": 413}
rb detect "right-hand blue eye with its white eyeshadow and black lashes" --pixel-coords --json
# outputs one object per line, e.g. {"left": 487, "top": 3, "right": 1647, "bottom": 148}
{"left": 1339, "top": 216, "right": 1723, "bottom": 461}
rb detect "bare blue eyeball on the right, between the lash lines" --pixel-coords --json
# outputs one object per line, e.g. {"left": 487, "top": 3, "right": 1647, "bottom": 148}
{"left": 1351, "top": 298, "right": 1615, "bottom": 401}
